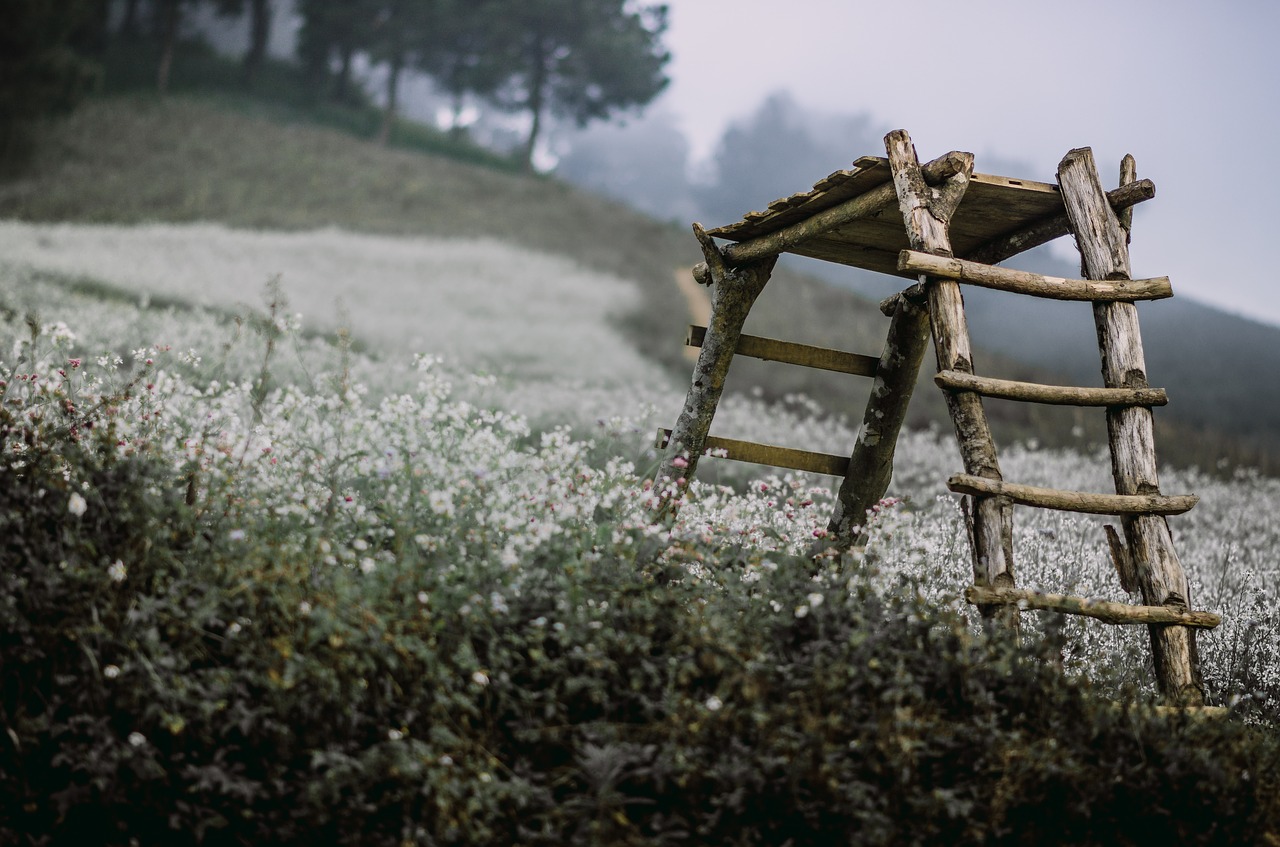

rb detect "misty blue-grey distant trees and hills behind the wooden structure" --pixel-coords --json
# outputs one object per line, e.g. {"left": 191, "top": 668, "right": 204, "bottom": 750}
{"left": 557, "top": 92, "right": 1280, "bottom": 478}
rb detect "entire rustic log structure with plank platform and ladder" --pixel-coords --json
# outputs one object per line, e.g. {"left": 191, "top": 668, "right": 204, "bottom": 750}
{"left": 658, "top": 131, "right": 1220, "bottom": 705}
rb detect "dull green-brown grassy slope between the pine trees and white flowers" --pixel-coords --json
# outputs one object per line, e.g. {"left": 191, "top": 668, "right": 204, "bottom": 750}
{"left": 0, "top": 95, "right": 1257, "bottom": 478}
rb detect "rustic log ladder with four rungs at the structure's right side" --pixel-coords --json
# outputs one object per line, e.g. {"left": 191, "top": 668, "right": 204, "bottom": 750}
{"left": 886, "top": 131, "right": 1221, "bottom": 706}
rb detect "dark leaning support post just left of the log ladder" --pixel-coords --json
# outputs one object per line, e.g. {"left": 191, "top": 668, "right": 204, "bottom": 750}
{"left": 814, "top": 297, "right": 929, "bottom": 553}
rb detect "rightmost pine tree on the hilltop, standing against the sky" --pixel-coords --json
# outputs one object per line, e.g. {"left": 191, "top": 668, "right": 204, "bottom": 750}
{"left": 492, "top": 0, "right": 671, "bottom": 168}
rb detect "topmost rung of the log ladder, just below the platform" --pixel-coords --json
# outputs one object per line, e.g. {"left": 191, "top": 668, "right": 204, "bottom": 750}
{"left": 897, "top": 249, "right": 1174, "bottom": 302}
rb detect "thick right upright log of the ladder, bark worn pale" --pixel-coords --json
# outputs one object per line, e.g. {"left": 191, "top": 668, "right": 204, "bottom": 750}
{"left": 1057, "top": 147, "right": 1204, "bottom": 705}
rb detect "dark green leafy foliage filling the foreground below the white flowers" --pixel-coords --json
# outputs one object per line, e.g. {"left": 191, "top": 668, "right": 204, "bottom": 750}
{"left": 0, "top": 377, "right": 1280, "bottom": 844}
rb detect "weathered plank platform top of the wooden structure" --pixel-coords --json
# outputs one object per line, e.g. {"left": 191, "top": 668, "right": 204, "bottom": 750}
{"left": 709, "top": 156, "right": 1065, "bottom": 278}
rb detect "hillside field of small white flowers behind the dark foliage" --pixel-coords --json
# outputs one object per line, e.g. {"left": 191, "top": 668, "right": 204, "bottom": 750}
{"left": 0, "top": 223, "right": 1280, "bottom": 708}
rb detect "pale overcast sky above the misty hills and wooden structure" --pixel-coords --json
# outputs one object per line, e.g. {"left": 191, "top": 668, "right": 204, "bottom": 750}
{"left": 658, "top": 0, "right": 1280, "bottom": 325}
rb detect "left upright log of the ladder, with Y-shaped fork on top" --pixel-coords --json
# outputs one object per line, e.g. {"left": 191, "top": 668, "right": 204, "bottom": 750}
{"left": 884, "top": 129, "right": 1018, "bottom": 616}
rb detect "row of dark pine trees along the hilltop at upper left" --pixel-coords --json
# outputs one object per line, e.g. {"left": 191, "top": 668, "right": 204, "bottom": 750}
{"left": 0, "top": 0, "right": 669, "bottom": 171}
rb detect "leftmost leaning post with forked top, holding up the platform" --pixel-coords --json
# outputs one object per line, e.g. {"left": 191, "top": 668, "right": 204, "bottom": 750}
{"left": 655, "top": 224, "right": 777, "bottom": 506}
